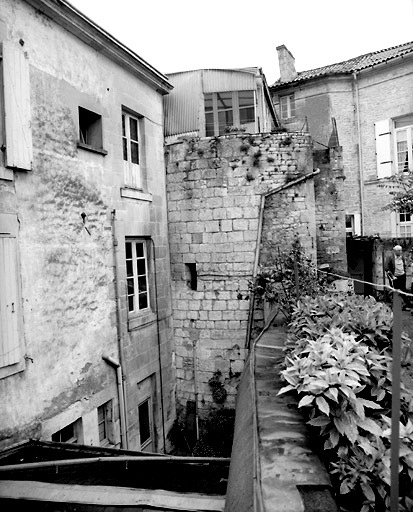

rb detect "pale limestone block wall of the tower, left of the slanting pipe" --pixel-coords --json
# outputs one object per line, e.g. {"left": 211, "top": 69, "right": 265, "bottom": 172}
{"left": 167, "top": 133, "right": 312, "bottom": 412}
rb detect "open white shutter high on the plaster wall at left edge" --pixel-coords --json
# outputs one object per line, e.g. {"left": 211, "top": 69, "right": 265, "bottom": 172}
{"left": 3, "top": 41, "right": 33, "bottom": 170}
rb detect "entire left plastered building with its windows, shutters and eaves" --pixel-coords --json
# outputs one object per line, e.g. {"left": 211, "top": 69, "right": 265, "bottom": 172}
{"left": 0, "top": 0, "right": 175, "bottom": 451}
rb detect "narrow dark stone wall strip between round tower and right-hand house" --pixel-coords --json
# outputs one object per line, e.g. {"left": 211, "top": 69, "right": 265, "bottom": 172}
{"left": 314, "top": 147, "right": 347, "bottom": 272}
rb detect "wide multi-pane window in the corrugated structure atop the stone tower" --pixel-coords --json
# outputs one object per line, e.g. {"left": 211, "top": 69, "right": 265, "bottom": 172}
{"left": 204, "top": 91, "right": 255, "bottom": 137}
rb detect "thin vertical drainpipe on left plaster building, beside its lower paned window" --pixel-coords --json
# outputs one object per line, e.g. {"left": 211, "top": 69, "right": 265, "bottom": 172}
{"left": 110, "top": 210, "right": 129, "bottom": 448}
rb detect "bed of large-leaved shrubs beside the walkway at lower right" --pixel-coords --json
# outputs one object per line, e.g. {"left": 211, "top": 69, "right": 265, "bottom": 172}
{"left": 280, "top": 295, "right": 413, "bottom": 512}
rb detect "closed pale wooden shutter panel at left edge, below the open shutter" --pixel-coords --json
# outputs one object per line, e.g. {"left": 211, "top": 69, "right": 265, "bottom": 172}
{"left": 0, "top": 235, "right": 21, "bottom": 367}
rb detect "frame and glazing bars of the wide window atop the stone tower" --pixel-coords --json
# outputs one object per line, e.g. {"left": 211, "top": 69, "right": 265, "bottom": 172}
{"left": 204, "top": 89, "right": 257, "bottom": 137}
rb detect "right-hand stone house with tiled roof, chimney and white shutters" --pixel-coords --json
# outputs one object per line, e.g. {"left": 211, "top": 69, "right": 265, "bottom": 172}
{"left": 270, "top": 42, "right": 413, "bottom": 238}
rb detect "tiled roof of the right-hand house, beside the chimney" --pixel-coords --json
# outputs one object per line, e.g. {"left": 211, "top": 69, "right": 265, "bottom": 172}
{"left": 272, "top": 41, "right": 413, "bottom": 87}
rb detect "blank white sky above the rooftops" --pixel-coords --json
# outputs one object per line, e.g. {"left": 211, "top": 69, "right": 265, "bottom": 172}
{"left": 68, "top": 0, "right": 413, "bottom": 85}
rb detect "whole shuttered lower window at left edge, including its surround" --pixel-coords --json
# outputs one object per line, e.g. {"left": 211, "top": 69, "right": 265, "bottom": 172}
{"left": 0, "top": 214, "right": 25, "bottom": 378}
